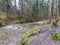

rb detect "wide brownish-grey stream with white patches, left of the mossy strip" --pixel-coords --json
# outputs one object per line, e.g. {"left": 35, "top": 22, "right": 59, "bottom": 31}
{"left": 0, "top": 23, "right": 41, "bottom": 45}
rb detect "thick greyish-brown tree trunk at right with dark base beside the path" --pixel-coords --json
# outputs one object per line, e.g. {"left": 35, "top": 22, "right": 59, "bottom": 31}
{"left": 52, "top": 0, "right": 58, "bottom": 26}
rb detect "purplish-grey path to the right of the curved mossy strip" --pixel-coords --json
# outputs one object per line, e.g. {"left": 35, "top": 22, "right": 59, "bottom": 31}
{"left": 27, "top": 26, "right": 60, "bottom": 45}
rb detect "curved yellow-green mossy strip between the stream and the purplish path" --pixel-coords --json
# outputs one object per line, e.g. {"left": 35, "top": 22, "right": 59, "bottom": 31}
{"left": 21, "top": 25, "right": 43, "bottom": 45}
